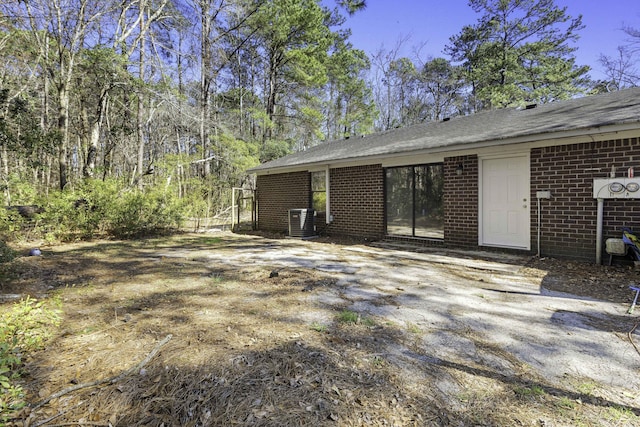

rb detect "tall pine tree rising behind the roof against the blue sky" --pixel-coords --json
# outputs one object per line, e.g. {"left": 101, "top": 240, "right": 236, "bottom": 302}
{"left": 446, "top": 0, "right": 589, "bottom": 109}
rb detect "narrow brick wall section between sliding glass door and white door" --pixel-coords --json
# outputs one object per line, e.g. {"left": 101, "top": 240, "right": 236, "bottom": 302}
{"left": 444, "top": 155, "right": 478, "bottom": 248}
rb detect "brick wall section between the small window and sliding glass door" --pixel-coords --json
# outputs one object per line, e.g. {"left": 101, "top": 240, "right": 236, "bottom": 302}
{"left": 327, "top": 165, "right": 384, "bottom": 239}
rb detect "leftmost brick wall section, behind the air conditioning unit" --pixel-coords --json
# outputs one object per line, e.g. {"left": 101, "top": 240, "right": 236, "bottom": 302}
{"left": 256, "top": 172, "right": 311, "bottom": 233}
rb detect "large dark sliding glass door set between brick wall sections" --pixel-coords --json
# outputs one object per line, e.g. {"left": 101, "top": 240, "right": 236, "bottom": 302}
{"left": 385, "top": 163, "right": 444, "bottom": 239}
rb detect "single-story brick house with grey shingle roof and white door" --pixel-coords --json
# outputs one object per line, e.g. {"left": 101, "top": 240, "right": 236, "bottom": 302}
{"left": 249, "top": 88, "right": 640, "bottom": 262}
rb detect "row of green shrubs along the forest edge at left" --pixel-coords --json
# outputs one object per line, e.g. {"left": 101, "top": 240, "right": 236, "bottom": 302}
{"left": 0, "top": 179, "right": 194, "bottom": 244}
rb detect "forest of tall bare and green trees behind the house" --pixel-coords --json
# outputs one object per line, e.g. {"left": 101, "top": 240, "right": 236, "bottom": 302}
{"left": 0, "top": 0, "right": 640, "bottom": 240}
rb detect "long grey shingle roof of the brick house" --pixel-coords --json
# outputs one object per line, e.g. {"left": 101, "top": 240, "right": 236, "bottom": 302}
{"left": 249, "top": 88, "right": 640, "bottom": 173}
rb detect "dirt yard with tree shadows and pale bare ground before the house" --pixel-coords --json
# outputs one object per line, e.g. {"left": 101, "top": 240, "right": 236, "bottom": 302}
{"left": 0, "top": 232, "right": 640, "bottom": 427}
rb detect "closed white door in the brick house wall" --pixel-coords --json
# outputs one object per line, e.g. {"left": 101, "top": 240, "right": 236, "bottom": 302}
{"left": 480, "top": 156, "right": 531, "bottom": 249}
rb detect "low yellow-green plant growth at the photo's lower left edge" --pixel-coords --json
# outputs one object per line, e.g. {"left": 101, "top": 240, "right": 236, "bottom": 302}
{"left": 0, "top": 297, "right": 61, "bottom": 422}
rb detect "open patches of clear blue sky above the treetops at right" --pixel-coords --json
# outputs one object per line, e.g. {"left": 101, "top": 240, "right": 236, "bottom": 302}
{"left": 336, "top": 0, "right": 640, "bottom": 79}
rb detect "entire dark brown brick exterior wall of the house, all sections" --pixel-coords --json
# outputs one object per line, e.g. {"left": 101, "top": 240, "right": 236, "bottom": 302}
{"left": 257, "top": 138, "right": 640, "bottom": 261}
